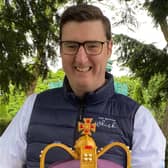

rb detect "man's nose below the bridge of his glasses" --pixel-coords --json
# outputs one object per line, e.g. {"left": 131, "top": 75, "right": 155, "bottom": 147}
{"left": 75, "top": 45, "right": 88, "bottom": 64}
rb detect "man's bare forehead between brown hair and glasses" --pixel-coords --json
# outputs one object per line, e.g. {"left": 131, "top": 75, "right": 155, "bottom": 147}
{"left": 62, "top": 20, "right": 106, "bottom": 42}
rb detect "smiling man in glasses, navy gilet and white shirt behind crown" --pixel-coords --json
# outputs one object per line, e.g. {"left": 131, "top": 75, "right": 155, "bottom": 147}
{"left": 0, "top": 5, "right": 166, "bottom": 168}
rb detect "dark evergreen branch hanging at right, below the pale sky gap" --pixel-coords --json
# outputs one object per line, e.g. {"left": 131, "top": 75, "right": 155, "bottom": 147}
{"left": 114, "top": 34, "right": 168, "bottom": 84}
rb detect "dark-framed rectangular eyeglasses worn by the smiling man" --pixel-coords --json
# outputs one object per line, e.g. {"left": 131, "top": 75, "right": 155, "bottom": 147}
{"left": 60, "top": 41, "right": 108, "bottom": 56}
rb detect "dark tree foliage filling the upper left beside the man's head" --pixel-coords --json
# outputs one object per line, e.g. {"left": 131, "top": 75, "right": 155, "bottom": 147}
{"left": 0, "top": 0, "right": 67, "bottom": 92}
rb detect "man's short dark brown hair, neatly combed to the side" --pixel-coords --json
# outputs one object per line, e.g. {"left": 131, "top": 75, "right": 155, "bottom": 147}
{"left": 60, "top": 4, "right": 111, "bottom": 40}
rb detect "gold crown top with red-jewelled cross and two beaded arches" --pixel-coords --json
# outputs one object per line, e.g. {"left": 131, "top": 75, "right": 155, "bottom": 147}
{"left": 40, "top": 118, "right": 131, "bottom": 168}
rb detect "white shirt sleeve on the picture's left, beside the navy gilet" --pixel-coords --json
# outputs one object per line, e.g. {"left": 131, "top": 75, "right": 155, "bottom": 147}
{"left": 0, "top": 94, "right": 36, "bottom": 168}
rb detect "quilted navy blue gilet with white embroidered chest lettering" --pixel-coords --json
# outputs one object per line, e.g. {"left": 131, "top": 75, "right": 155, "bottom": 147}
{"left": 26, "top": 73, "right": 139, "bottom": 168}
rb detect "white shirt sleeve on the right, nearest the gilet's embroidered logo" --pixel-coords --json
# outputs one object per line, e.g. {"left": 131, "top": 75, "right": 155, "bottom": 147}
{"left": 132, "top": 106, "right": 166, "bottom": 168}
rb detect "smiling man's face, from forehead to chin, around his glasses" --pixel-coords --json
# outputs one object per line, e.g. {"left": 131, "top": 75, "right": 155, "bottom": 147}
{"left": 60, "top": 21, "right": 112, "bottom": 96}
